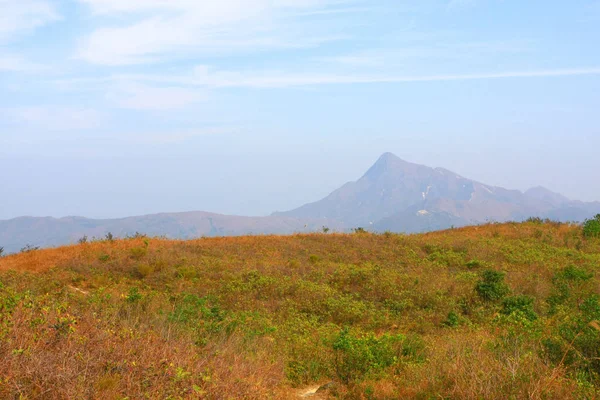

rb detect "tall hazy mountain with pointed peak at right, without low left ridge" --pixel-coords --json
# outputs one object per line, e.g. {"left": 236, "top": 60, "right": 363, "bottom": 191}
{"left": 274, "top": 153, "right": 600, "bottom": 232}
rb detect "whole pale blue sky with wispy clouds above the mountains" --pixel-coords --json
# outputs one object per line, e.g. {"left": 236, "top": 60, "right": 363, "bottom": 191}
{"left": 0, "top": 0, "right": 600, "bottom": 219}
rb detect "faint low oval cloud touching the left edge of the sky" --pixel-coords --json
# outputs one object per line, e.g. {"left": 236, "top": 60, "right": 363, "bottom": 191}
{"left": 0, "top": 106, "right": 104, "bottom": 131}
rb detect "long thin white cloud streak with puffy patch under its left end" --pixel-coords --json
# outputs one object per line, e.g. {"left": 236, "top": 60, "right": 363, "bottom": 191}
{"left": 50, "top": 66, "right": 600, "bottom": 94}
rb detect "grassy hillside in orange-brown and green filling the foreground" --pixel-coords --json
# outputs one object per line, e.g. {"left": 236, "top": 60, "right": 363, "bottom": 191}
{"left": 0, "top": 222, "right": 600, "bottom": 399}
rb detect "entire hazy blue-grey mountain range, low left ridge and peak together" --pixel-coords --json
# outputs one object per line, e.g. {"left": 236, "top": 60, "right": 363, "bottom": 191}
{"left": 0, "top": 153, "right": 600, "bottom": 252}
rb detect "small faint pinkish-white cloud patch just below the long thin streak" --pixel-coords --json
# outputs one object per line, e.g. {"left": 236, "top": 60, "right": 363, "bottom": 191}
{"left": 107, "top": 82, "right": 206, "bottom": 110}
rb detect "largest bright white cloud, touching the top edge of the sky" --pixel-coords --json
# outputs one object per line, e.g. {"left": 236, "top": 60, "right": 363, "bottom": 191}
{"left": 78, "top": 0, "right": 354, "bottom": 65}
